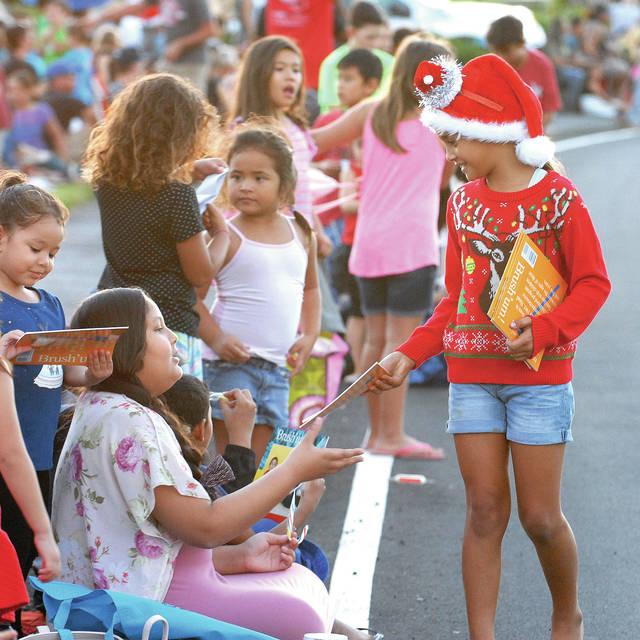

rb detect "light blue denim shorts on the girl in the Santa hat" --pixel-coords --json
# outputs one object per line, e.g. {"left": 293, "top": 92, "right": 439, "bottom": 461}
{"left": 447, "top": 382, "right": 575, "bottom": 444}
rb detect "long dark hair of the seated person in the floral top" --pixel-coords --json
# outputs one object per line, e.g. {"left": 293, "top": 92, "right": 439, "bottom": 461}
{"left": 71, "top": 288, "right": 202, "bottom": 480}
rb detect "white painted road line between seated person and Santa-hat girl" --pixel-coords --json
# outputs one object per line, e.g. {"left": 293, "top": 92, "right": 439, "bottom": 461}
{"left": 329, "top": 453, "right": 393, "bottom": 627}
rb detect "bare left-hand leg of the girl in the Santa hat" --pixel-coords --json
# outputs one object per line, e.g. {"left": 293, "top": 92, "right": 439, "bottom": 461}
{"left": 454, "top": 433, "right": 511, "bottom": 640}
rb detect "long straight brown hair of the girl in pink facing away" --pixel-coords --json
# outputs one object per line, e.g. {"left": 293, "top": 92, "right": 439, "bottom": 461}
{"left": 371, "top": 34, "right": 451, "bottom": 153}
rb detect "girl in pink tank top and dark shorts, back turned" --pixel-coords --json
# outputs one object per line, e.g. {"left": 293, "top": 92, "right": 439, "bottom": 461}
{"left": 312, "top": 35, "right": 451, "bottom": 459}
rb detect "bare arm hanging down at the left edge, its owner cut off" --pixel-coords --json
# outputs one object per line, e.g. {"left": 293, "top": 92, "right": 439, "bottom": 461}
{"left": 0, "top": 364, "right": 60, "bottom": 582}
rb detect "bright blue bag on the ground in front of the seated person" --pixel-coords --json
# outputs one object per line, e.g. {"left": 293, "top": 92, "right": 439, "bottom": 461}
{"left": 30, "top": 577, "right": 274, "bottom": 640}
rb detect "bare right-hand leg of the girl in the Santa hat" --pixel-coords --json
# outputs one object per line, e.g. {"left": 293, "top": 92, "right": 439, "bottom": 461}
{"left": 511, "top": 443, "right": 583, "bottom": 640}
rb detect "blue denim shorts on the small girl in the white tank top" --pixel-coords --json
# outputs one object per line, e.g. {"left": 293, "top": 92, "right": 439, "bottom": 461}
{"left": 202, "top": 358, "right": 290, "bottom": 427}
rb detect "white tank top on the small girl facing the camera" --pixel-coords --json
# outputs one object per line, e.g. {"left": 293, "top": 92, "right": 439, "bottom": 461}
{"left": 202, "top": 218, "right": 307, "bottom": 367}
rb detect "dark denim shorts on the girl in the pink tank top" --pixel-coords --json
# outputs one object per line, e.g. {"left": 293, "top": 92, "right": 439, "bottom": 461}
{"left": 357, "top": 265, "right": 436, "bottom": 318}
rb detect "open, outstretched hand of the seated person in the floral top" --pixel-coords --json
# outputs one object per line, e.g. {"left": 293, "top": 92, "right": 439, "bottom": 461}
{"left": 281, "top": 420, "right": 364, "bottom": 482}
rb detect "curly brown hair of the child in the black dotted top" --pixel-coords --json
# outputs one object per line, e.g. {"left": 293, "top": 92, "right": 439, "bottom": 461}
{"left": 83, "top": 73, "right": 218, "bottom": 194}
